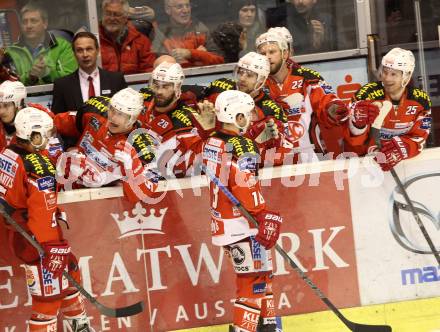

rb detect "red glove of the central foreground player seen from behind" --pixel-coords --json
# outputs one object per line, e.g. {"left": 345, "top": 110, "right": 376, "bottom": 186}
{"left": 255, "top": 210, "right": 283, "bottom": 249}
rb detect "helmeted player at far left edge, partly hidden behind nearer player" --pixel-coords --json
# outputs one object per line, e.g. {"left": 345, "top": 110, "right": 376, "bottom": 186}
{"left": 0, "top": 81, "right": 63, "bottom": 163}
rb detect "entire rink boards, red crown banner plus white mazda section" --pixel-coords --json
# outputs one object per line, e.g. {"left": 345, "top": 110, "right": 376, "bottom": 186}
{"left": 0, "top": 149, "right": 440, "bottom": 331}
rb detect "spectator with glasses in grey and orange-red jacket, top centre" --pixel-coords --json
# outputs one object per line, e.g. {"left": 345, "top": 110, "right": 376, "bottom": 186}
{"left": 153, "top": 0, "right": 223, "bottom": 67}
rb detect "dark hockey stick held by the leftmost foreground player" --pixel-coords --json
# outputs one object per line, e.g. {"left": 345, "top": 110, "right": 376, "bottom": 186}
{"left": 0, "top": 203, "right": 144, "bottom": 317}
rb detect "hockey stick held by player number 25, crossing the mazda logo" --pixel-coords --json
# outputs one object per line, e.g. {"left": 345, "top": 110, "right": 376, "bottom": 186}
{"left": 371, "top": 101, "right": 440, "bottom": 266}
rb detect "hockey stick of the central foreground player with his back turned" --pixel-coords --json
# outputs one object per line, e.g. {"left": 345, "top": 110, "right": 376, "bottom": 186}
{"left": 201, "top": 165, "right": 392, "bottom": 332}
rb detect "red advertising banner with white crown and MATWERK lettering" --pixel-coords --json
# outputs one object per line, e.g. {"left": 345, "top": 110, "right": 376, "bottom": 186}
{"left": 0, "top": 172, "right": 360, "bottom": 331}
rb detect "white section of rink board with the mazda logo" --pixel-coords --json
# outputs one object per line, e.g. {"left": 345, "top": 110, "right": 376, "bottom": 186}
{"left": 349, "top": 149, "right": 440, "bottom": 305}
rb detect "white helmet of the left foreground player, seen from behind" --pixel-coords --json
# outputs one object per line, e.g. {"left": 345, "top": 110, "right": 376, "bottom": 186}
{"left": 14, "top": 107, "right": 53, "bottom": 148}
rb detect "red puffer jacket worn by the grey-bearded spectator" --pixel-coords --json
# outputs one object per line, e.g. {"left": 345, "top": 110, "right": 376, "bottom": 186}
{"left": 99, "top": 23, "right": 156, "bottom": 74}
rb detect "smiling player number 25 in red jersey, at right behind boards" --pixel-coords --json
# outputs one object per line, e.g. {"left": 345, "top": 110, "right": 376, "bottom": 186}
{"left": 346, "top": 48, "right": 432, "bottom": 171}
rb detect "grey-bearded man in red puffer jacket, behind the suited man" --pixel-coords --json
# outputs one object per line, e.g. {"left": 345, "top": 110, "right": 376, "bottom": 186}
{"left": 99, "top": 0, "right": 156, "bottom": 74}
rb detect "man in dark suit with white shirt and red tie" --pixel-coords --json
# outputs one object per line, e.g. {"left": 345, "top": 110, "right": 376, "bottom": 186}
{"left": 52, "top": 31, "right": 127, "bottom": 113}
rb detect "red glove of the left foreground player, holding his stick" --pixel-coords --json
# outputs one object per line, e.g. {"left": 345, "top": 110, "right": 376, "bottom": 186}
{"left": 42, "top": 240, "right": 72, "bottom": 278}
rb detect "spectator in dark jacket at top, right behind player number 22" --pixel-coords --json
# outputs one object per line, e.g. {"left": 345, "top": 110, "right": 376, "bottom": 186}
{"left": 267, "top": 0, "right": 336, "bottom": 54}
